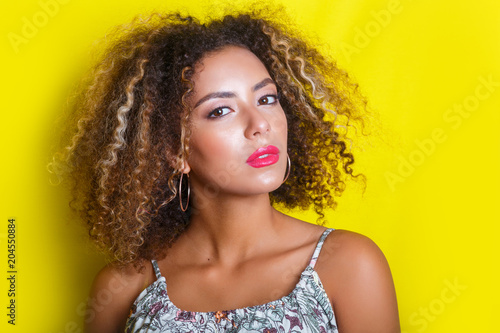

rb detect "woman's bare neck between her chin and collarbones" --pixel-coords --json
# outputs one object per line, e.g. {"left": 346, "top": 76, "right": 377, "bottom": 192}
{"left": 184, "top": 193, "right": 282, "bottom": 263}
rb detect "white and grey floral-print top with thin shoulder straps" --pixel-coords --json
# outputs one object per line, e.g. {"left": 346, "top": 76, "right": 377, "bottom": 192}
{"left": 125, "top": 229, "right": 338, "bottom": 333}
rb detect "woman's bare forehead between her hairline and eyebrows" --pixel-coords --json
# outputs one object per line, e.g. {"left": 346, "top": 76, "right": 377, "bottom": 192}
{"left": 193, "top": 46, "right": 270, "bottom": 94}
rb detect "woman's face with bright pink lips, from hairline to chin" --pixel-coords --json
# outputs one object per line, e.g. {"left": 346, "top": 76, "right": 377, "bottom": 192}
{"left": 184, "top": 46, "right": 287, "bottom": 196}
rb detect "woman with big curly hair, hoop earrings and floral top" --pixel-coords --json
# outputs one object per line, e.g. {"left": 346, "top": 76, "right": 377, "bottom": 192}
{"left": 52, "top": 9, "right": 399, "bottom": 333}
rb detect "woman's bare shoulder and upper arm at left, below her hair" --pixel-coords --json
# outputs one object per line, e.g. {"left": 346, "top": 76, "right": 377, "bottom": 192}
{"left": 85, "top": 264, "right": 154, "bottom": 333}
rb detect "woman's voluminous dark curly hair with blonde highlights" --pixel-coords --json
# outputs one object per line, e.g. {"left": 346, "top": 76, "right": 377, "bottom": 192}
{"left": 52, "top": 8, "right": 366, "bottom": 266}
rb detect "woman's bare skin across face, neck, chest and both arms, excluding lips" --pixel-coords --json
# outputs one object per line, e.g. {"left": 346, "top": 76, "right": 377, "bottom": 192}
{"left": 86, "top": 46, "right": 400, "bottom": 333}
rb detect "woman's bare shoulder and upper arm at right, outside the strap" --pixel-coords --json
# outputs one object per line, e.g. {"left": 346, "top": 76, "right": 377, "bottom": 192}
{"left": 318, "top": 230, "right": 400, "bottom": 333}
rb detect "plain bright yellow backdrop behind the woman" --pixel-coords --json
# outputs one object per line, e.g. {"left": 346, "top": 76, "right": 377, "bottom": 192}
{"left": 0, "top": 0, "right": 500, "bottom": 333}
